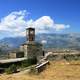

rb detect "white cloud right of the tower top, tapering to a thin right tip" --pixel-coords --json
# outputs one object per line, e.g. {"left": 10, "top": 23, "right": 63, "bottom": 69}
{"left": 28, "top": 16, "right": 70, "bottom": 33}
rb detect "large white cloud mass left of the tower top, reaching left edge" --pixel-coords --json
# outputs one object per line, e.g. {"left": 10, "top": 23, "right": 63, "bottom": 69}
{"left": 0, "top": 10, "right": 28, "bottom": 36}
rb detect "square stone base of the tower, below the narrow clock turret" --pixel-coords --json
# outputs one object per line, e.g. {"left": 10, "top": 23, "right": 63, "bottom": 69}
{"left": 24, "top": 42, "right": 43, "bottom": 59}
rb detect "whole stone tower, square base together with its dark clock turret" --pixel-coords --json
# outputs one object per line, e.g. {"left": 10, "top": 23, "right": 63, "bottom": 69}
{"left": 20, "top": 28, "right": 43, "bottom": 60}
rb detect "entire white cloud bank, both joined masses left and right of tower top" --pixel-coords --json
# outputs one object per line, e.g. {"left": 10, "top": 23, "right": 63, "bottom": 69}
{"left": 0, "top": 10, "right": 70, "bottom": 37}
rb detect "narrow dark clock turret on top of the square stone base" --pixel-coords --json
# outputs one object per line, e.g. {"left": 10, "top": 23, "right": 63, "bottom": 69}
{"left": 26, "top": 28, "right": 35, "bottom": 42}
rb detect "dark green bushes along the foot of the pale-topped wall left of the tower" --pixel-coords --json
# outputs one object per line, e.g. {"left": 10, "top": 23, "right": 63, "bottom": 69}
{"left": 5, "top": 58, "right": 37, "bottom": 74}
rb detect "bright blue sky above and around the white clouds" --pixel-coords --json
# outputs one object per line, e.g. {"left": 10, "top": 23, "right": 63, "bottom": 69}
{"left": 0, "top": 0, "right": 80, "bottom": 38}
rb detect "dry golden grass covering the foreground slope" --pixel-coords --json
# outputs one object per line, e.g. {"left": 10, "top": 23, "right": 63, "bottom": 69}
{"left": 0, "top": 60, "right": 80, "bottom": 80}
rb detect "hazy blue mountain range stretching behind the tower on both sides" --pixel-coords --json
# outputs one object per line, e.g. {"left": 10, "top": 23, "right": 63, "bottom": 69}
{"left": 0, "top": 33, "right": 80, "bottom": 49}
